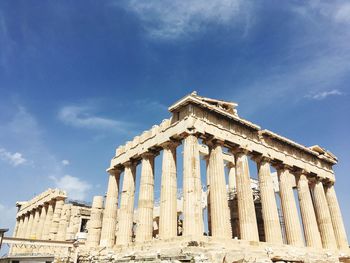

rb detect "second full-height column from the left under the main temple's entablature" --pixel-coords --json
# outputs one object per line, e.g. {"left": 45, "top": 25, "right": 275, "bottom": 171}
{"left": 116, "top": 161, "right": 136, "bottom": 245}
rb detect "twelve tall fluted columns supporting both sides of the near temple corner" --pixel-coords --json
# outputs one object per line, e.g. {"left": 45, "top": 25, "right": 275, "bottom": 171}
{"left": 100, "top": 134, "right": 348, "bottom": 253}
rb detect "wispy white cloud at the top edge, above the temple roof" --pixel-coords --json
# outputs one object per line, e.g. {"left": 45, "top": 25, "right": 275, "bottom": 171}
{"left": 121, "top": 0, "right": 249, "bottom": 40}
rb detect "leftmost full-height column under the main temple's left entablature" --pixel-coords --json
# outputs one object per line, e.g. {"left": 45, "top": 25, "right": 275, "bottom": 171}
{"left": 100, "top": 169, "right": 121, "bottom": 248}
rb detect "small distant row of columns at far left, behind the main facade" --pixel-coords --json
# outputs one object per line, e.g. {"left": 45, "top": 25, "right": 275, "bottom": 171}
{"left": 14, "top": 199, "right": 70, "bottom": 240}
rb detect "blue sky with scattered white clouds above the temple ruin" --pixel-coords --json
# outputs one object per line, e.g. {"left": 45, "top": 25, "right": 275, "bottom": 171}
{"left": 0, "top": 0, "right": 350, "bottom": 243}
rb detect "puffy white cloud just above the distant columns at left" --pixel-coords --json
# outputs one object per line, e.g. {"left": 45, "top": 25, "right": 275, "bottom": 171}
{"left": 49, "top": 175, "right": 92, "bottom": 200}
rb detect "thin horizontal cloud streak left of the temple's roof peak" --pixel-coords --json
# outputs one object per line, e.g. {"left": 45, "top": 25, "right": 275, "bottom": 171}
{"left": 58, "top": 106, "right": 129, "bottom": 132}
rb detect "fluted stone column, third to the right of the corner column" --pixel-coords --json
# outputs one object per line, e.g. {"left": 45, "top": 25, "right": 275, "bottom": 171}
{"left": 257, "top": 157, "right": 283, "bottom": 244}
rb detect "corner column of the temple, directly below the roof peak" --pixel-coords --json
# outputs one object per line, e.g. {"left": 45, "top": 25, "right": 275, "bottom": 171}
{"left": 183, "top": 134, "right": 204, "bottom": 237}
